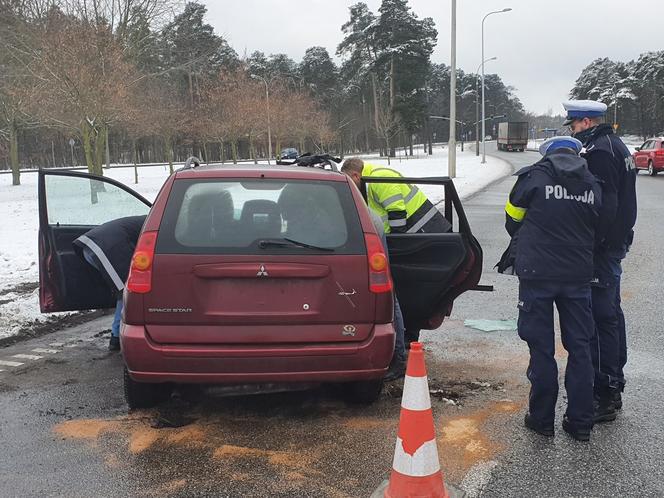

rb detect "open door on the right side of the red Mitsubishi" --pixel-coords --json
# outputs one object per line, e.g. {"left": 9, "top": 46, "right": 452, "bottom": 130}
{"left": 363, "top": 177, "right": 483, "bottom": 330}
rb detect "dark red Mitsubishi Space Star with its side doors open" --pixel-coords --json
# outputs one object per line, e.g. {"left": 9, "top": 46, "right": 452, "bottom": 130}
{"left": 39, "top": 161, "right": 482, "bottom": 408}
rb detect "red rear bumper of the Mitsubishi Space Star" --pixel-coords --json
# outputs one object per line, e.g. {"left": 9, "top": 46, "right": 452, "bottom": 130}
{"left": 120, "top": 324, "right": 394, "bottom": 384}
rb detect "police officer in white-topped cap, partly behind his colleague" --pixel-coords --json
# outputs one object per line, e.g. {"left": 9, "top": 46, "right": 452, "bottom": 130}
{"left": 563, "top": 100, "right": 636, "bottom": 422}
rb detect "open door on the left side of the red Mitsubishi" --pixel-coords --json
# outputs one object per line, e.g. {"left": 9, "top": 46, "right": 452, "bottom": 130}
{"left": 38, "top": 170, "right": 151, "bottom": 313}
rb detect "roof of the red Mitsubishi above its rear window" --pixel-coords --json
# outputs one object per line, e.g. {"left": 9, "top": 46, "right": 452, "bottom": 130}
{"left": 176, "top": 164, "right": 348, "bottom": 182}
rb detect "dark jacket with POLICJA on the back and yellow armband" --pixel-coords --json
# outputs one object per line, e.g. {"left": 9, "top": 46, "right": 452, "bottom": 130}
{"left": 498, "top": 149, "right": 602, "bottom": 282}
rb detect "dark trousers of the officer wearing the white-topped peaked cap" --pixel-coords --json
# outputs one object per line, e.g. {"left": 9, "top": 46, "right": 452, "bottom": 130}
{"left": 591, "top": 251, "right": 627, "bottom": 395}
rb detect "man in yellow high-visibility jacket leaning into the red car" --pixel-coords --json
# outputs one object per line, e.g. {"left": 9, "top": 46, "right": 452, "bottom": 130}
{"left": 341, "top": 158, "right": 452, "bottom": 344}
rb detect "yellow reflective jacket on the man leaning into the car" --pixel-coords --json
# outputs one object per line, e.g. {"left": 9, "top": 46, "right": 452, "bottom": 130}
{"left": 362, "top": 163, "right": 430, "bottom": 233}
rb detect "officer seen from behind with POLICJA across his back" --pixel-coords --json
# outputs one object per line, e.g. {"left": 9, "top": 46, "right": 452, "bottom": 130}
{"left": 499, "top": 137, "right": 602, "bottom": 441}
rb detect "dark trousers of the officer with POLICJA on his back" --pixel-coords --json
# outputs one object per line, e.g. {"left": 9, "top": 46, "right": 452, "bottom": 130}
{"left": 518, "top": 279, "right": 593, "bottom": 429}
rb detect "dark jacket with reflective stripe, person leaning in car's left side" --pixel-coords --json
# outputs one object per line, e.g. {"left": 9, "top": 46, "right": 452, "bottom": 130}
{"left": 73, "top": 216, "right": 146, "bottom": 291}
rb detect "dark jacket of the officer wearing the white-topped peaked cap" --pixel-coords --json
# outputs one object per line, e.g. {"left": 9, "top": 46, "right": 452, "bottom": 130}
{"left": 575, "top": 124, "right": 637, "bottom": 251}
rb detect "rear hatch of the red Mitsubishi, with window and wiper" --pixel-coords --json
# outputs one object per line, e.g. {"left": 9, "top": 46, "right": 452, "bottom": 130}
{"left": 144, "top": 178, "right": 376, "bottom": 345}
